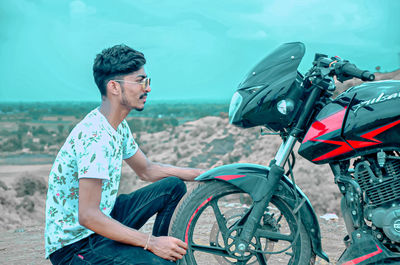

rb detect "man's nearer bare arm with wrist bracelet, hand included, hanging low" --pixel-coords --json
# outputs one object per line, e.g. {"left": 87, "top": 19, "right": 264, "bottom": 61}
{"left": 79, "top": 178, "right": 187, "bottom": 261}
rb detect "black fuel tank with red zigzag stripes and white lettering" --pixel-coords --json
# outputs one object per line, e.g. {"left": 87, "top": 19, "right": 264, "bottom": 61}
{"left": 299, "top": 80, "right": 400, "bottom": 164}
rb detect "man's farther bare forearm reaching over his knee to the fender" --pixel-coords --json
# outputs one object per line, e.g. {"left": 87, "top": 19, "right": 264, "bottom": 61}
{"left": 125, "top": 146, "right": 204, "bottom": 182}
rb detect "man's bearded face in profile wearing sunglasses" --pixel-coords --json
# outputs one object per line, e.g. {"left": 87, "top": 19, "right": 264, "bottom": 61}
{"left": 118, "top": 68, "right": 151, "bottom": 111}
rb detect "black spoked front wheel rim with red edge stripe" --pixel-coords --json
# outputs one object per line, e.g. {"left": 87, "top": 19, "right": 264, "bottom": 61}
{"left": 185, "top": 190, "right": 301, "bottom": 265}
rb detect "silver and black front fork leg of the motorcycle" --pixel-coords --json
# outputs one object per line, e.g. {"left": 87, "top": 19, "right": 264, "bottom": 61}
{"left": 236, "top": 135, "right": 297, "bottom": 255}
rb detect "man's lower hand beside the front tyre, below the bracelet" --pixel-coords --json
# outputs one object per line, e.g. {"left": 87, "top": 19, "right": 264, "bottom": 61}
{"left": 148, "top": 236, "right": 187, "bottom": 261}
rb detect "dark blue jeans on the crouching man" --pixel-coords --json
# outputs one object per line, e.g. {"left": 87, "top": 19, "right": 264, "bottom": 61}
{"left": 50, "top": 177, "right": 186, "bottom": 265}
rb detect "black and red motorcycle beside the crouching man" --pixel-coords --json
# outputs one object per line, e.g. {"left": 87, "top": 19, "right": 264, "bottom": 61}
{"left": 171, "top": 42, "right": 400, "bottom": 265}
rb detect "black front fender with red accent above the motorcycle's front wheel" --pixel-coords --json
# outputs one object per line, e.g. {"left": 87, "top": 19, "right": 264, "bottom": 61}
{"left": 196, "top": 163, "right": 329, "bottom": 262}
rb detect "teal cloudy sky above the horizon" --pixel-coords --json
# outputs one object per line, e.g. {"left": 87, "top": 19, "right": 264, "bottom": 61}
{"left": 0, "top": 0, "right": 400, "bottom": 102}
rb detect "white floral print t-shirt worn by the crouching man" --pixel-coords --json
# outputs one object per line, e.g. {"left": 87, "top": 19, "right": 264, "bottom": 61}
{"left": 45, "top": 108, "right": 138, "bottom": 258}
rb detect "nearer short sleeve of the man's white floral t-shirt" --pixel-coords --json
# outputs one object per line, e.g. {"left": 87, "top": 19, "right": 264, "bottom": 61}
{"left": 76, "top": 130, "right": 110, "bottom": 180}
